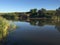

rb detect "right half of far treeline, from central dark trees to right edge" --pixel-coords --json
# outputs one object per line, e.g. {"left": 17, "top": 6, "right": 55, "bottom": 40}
{"left": 30, "top": 7, "right": 60, "bottom": 18}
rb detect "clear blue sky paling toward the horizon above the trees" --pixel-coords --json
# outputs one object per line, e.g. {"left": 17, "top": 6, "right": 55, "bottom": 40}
{"left": 0, "top": 0, "right": 60, "bottom": 12}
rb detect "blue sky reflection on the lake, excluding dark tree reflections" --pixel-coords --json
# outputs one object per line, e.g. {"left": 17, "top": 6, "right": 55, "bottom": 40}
{"left": 4, "top": 21, "right": 60, "bottom": 44}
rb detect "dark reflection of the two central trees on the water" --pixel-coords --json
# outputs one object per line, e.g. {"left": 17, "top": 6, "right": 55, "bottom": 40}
{"left": 30, "top": 19, "right": 51, "bottom": 26}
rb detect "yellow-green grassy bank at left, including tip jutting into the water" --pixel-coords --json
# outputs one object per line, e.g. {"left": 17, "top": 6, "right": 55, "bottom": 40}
{"left": 0, "top": 17, "right": 16, "bottom": 40}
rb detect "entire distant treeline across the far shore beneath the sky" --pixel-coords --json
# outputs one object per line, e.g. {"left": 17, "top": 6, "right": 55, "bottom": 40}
{"left": 0, "top": 7, "right": 60, "bottom": 19}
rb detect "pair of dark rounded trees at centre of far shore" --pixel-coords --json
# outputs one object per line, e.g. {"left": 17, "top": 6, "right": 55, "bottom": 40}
{"left": 30, "top": 8, "right": 52, "bottom": 18}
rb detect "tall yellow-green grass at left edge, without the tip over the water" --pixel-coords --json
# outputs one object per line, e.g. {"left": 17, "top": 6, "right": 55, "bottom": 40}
{"left": 0, "top": 17, "right": 10, "bottom": 39}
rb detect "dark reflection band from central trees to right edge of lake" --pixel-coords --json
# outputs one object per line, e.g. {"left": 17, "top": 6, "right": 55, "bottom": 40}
{"left": 30, "top": 19, "right": 60, "bottom": 32}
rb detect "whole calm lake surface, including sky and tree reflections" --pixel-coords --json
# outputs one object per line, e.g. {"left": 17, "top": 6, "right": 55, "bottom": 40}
{"left": 1, "top": 20, "right": 60, "bottom": 45}
